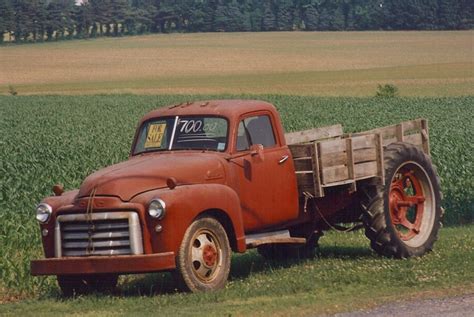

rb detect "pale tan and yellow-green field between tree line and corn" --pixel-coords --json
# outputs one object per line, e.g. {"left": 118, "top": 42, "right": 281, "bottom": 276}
{"left": 0, "top": 31, "right": 474, "bottom": 96}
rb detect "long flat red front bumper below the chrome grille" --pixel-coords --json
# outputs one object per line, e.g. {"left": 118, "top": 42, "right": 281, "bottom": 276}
{"left": 31, "top": 252, "right": 176, "bottom": 275}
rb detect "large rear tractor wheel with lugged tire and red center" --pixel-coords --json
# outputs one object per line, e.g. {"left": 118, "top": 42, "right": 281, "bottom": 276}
{"left": 361, "top": 142, "right": 442, "bottom": 258}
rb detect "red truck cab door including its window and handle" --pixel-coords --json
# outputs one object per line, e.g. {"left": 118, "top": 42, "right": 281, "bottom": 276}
{"left": 233, "top": 113, "right": 298, "bottom": 231}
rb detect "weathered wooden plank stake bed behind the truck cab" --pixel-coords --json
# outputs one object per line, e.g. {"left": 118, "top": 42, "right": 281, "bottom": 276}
{"left": 285, "top": 119, "right": 430, "bottom": 197}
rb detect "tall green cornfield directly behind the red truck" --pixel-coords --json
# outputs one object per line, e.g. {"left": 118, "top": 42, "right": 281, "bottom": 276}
{"left": 0, "top": 95, "right": 474, "bottom": 297}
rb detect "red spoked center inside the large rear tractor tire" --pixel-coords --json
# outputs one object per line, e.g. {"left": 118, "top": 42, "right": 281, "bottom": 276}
{"left": 389, "top": 166, "right": 426, "bottom": 241}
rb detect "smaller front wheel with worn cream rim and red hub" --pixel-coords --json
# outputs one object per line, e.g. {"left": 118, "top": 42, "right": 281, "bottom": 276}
{"left": 174, "top": 217, "right": 231, "bottom": 292}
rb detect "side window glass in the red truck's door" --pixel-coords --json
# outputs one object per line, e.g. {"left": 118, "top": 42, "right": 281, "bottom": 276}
{"left": 237, "top": 115, "right": 276, "bottom": 151}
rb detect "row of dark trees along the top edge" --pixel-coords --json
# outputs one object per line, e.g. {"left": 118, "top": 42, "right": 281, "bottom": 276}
{"left": 0, "top": 0, "right": 474, "bottom": 43}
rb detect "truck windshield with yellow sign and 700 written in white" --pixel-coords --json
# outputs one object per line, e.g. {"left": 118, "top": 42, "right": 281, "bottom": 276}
{"left": 133, "top": 116, "right": 227, "bottom": 155}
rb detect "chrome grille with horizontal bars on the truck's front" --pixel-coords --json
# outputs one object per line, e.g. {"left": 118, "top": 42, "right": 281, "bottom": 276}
{"left": 55, "top": 212, "right": 143, "bottom": 257}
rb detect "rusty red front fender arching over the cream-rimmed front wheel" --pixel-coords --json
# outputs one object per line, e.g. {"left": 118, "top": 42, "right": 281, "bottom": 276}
{"left": 132, "top": 184, "right": 246, "bottom": 254}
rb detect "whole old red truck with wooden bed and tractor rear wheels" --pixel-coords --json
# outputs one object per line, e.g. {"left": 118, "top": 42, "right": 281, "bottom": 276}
{"left": 31, "top": 100, "right": 442, "bottom": 295}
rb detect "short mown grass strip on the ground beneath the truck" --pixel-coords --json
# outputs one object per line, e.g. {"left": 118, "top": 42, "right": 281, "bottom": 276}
{"left": 0, "top": 226, "right": 474, "bottom": 316}
